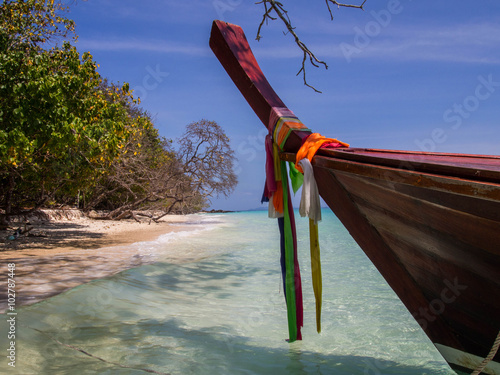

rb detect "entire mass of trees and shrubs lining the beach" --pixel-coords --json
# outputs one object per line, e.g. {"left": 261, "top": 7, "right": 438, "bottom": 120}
{"left": 0, "top": 0, "right": 236, "bottom": 220}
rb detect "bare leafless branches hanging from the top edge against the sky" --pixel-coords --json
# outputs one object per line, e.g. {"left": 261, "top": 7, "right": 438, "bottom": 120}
{"left": 256, "top": 0, "right": 366, "bottom": 92}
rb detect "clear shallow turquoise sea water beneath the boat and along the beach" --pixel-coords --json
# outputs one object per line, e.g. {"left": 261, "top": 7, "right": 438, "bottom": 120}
{"left": 0, "top": 211, "right": 454, "bottom": 375}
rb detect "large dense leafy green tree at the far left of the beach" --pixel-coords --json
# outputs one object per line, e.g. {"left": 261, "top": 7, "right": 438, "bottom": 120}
{"left": 0, "top": 1, "right": 136, "bottom": 225}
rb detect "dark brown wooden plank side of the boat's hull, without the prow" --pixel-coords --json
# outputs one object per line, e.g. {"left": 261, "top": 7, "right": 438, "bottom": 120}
{"left": 306, "top": 149, "right": 500, "bottom": 374}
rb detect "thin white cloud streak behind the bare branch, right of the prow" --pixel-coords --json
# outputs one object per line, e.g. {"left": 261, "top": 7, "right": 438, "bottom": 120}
{"left": 256, "top": 23, "right": 500, "bottom": 64}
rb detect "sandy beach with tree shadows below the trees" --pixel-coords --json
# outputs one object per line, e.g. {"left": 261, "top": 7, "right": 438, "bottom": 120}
{"left": 0, "top": 214, "right": 199, "bottom": 313}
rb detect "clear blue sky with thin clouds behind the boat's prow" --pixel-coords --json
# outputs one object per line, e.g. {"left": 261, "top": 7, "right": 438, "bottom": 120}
{"left": 70, "top": 0, "right": 500, "bottom": 210}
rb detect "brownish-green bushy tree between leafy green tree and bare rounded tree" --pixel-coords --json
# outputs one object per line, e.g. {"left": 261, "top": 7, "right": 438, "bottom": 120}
{"left": 83, "top": 97, "right": 182, "bottom": 219}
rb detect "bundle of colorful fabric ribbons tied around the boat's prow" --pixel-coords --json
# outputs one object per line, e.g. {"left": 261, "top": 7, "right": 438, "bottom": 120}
{"left": 262, "top": 108, "right": 349, "bottom": 342}
